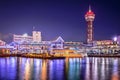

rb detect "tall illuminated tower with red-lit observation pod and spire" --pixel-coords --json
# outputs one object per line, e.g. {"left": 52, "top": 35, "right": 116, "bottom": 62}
{"left": 85, "top": 6, "right": 95, "bottom": 44}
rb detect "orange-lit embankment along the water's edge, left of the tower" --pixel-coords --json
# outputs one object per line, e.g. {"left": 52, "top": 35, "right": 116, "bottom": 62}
{"left": 0, "top": 53, "right": 83, "bottom": 59}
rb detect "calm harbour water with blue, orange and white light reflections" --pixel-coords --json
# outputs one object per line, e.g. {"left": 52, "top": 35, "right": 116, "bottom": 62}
{"left": 0, "top": 57, "right": 120, "bottom": 80}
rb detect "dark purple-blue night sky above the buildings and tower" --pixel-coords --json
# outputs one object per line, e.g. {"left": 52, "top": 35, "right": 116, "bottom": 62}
{"left": 0, "top": 0, "right": 120, "bottom": 41}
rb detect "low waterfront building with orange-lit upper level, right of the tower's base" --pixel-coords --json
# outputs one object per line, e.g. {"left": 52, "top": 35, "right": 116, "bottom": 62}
{"left": 86, "top": 40, "right": 119, "bottom": 54}
